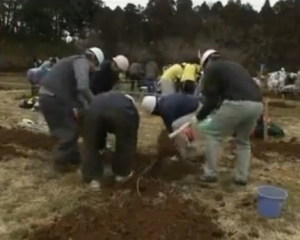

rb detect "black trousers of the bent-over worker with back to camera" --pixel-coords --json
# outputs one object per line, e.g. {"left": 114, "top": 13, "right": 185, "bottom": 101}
{"left": 81, "top": 108, "right": 139, "bottom": 182}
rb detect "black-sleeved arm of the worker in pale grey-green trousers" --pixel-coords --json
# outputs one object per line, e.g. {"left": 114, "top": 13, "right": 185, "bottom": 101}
{"left": 197, "top": 68, "right": 219, "bottom": 121}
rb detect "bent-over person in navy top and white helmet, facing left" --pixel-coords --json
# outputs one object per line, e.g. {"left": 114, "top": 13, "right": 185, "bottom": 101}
{"left": 141, "top": 93, "right": 201, "bottom": 159}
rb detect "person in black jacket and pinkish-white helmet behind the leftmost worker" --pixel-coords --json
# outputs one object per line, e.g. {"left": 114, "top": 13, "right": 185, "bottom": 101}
{"left": 90, "top": 55, "right": 129, "bottom": 95}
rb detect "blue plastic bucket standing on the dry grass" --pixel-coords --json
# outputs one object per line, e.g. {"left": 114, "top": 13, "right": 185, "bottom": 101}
{"left": 257, "top": 185, "right": 288, "bottom": 218}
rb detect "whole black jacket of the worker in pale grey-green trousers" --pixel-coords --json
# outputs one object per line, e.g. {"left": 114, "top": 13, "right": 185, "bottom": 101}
{"left": 197, "top": 60, "right": 262, "bottom": 120}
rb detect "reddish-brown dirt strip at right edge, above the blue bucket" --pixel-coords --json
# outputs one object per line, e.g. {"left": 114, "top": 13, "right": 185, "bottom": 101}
{"left": 252, "top": 138, "right": 300, "bottom": 160}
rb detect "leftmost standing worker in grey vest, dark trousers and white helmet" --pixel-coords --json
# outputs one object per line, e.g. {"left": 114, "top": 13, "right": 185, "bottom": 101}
{"left": 39, "top": 47, "right": 104, "bottom": 172}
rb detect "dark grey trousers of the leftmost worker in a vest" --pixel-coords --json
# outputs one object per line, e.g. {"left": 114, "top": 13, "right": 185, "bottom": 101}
{"left": 39, "top": 94, "right": 80, "bottom": 166}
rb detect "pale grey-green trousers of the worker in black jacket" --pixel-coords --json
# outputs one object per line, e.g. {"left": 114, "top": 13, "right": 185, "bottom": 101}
{"left": 198, "top": 101, "right": 263, "bottom": 180}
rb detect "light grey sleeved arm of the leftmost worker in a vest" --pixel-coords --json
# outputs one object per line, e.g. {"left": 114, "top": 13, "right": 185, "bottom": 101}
{"left": 73, "top": 59, "right": 94, "bottom": 105}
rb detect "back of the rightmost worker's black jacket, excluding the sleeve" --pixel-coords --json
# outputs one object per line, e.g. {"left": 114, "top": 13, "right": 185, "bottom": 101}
{"left": 207, "top": 60, "right": 262, "bottom": 102}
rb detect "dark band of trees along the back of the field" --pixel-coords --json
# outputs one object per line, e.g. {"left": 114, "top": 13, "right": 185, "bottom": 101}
{"left": 0, "top": 0, "right": 300, "bottom": 71}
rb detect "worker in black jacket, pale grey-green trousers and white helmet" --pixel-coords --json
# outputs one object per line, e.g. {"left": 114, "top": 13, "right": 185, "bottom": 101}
{"left": 193, "top": 49, "right": 263, "bottom": 185}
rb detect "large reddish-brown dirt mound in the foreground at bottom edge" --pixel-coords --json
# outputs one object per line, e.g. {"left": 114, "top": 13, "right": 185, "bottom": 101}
{"left": 31, "top": 194, "right": 224, "bottom": 240}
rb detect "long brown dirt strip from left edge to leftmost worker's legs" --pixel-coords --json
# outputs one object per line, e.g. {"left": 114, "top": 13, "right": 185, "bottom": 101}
{"left": 0, "top": 127, "right": 57, "bottom": 151}
